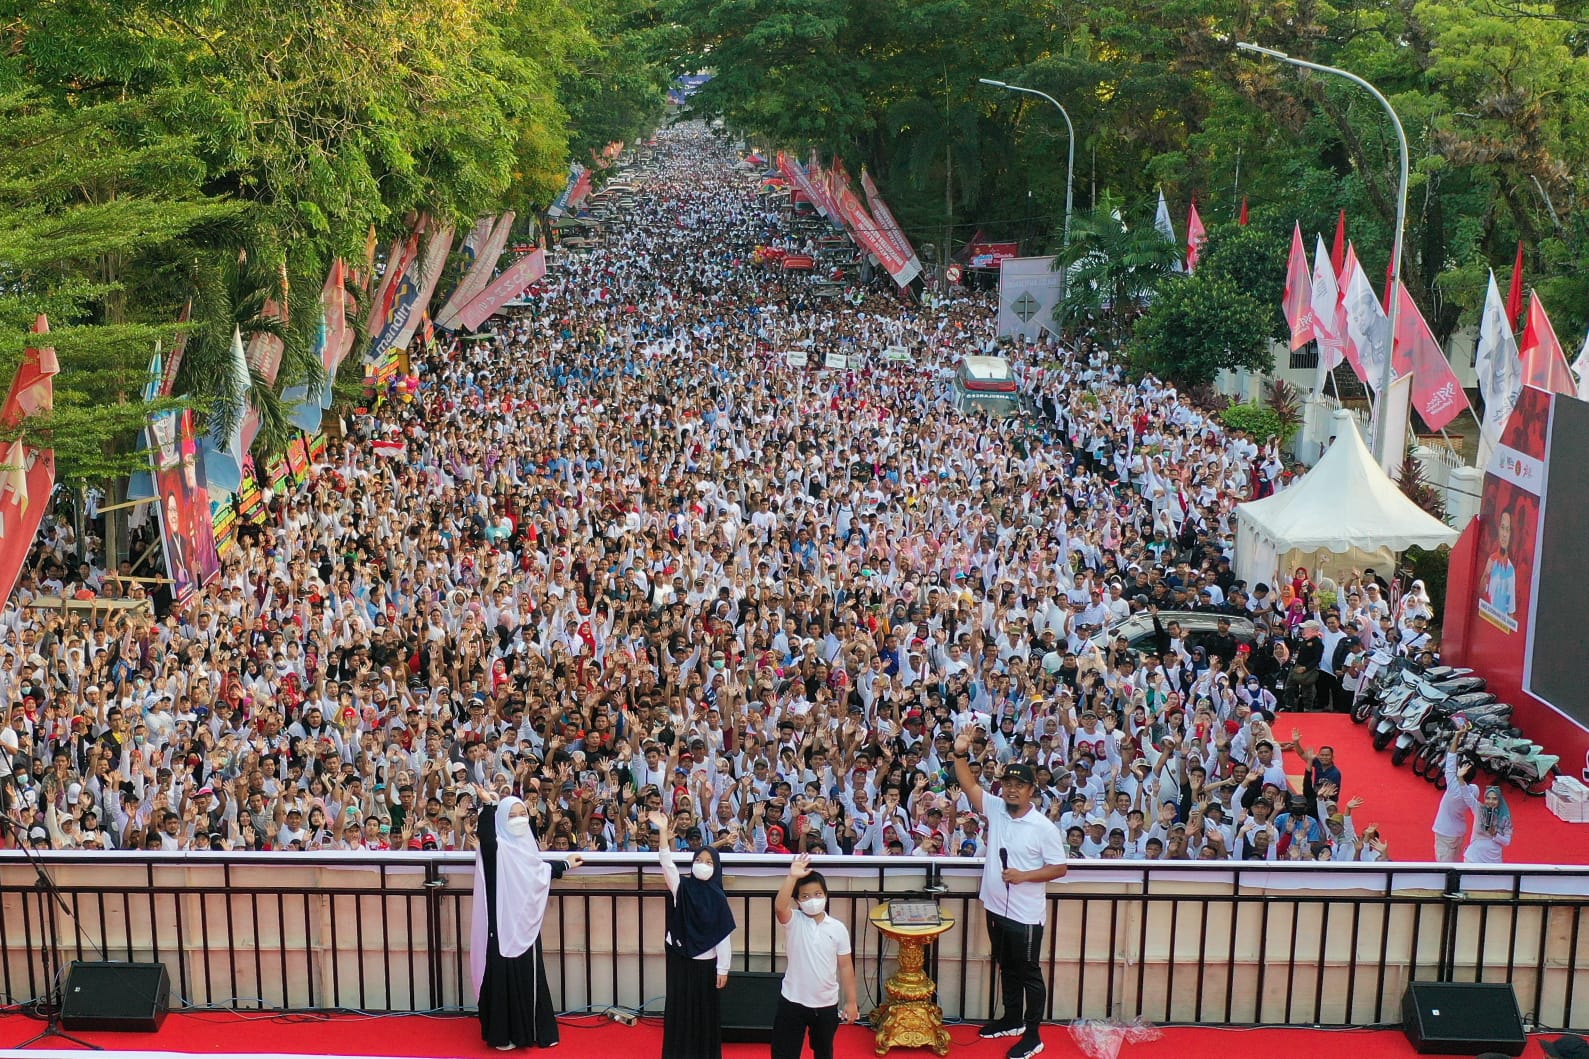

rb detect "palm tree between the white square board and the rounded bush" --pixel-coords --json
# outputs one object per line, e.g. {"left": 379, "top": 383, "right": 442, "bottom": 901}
{"left": 1054, "top": 191, "right": 1181, "bottom": 331}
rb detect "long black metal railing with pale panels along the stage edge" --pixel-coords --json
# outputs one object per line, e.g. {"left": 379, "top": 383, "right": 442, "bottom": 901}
{"left": 0, "top": 852, "right": 1589, "bottom": 1029}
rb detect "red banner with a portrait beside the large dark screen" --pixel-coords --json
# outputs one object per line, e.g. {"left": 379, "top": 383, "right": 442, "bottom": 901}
{"left": 1475, "top": 386, "right": 1551, "bottom": 642}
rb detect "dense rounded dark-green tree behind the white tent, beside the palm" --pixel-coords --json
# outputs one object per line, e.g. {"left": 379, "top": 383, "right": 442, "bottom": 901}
{"left": 1127, "top": 270, "right": 1270, "bottom": 386}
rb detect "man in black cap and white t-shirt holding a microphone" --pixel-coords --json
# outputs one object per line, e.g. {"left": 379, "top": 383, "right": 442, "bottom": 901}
{"left": 955, "top": 728, "right": 1065, "bottom": 1059}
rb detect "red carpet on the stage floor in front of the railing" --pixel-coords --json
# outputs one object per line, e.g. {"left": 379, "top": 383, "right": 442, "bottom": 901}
{"left": 0, "top": 1013, "right": 1563, "bottom": 1059}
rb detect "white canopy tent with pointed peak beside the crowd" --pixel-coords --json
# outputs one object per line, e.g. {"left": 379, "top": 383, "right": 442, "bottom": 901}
{"left": 1236, "top": 410, "right": 1457, "bottom": 585}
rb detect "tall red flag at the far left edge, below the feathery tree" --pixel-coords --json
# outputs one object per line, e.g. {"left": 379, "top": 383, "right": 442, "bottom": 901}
{"left": 0, "top": 316, "right": 60, "bottom": 603}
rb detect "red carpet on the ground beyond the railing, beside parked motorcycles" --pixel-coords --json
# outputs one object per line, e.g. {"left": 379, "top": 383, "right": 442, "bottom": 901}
{"left": 1274, "top": 714, "right": 1589, "bottom": 863}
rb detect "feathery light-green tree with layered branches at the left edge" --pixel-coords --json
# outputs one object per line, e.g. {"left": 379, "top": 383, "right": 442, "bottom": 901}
{"left": 0, "top": 92, "right": 240, "bottom": 483}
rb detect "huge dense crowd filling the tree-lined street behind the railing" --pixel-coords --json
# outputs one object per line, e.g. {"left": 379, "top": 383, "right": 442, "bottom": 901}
{"left": 0, "top": 126, "right": 1427, "bottom": 860}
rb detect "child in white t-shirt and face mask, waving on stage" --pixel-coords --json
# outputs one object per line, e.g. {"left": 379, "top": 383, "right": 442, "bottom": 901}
{"left": 772, "top": 854, "right": 860, "bottom": 1059}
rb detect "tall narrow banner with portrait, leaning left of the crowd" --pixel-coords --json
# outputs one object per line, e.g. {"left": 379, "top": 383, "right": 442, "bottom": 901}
{"left": 149, "top": 403, "right": 221, "bottom": 606}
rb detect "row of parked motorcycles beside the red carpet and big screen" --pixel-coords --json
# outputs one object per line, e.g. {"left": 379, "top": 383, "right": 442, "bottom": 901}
{"left": 1352, "top": 650, "right": 1560, "bottom": 797}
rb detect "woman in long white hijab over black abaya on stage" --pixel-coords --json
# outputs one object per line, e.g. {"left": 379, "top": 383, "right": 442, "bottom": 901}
{"left": 469, "top": 798, "right": 582, "bottom": 1051}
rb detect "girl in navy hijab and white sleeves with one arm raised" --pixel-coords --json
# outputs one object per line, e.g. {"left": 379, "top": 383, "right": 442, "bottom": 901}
{"left": 650, "top": 813, "right": 734, "bottom": 1059}
